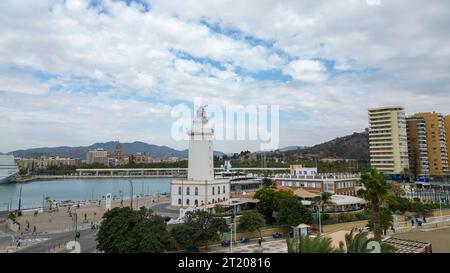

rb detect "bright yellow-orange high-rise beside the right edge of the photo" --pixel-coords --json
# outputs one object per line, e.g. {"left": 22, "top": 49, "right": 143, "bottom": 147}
{"left": 408, "top": 112, "right": 449, "bottom": 176}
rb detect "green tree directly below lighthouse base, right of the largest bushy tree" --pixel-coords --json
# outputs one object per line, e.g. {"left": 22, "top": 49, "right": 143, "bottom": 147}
{"left": 184, "top": 210, "right": 227, "bottom": 249}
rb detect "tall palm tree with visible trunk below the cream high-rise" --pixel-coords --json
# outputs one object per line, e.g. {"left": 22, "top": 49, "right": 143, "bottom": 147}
{"left": 358, "top": 169, "right": 392, "bottom": 240}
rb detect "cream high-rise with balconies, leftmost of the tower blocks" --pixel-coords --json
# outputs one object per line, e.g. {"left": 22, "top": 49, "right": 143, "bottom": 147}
{"left": 369, "top": 107, "right": 409, "bottom": 174}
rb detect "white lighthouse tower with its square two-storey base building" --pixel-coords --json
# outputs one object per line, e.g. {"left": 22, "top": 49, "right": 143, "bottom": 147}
{"left": 171, "top": 107, "right": 230, "bottom": 207}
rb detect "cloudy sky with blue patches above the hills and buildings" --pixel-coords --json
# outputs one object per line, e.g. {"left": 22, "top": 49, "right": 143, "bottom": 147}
{"left": 0, "top": 0, "right": 450, "bottom": 152}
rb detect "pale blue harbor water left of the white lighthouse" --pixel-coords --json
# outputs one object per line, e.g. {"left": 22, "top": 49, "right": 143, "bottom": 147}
{"left": 0, "top": 178, "right": 171, "bottom": 211}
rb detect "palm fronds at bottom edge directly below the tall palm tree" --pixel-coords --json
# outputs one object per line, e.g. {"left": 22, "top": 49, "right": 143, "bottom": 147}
{"left": 345, "top": 229, "right": 395, "bottom": 253}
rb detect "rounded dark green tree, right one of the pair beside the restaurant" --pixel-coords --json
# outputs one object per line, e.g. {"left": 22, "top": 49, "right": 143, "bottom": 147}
{"left": 277, "top": 198, "right": 313, "bottom": 226}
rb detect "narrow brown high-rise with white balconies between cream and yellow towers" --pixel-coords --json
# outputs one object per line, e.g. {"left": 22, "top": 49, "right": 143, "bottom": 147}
{"left": 406, "top": 117, "right": 430, "bottom": 177}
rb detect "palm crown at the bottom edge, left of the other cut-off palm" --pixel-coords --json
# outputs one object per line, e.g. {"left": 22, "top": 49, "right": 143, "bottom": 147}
{"left": 286, "top": 236, "right": 343, "bottom": 253}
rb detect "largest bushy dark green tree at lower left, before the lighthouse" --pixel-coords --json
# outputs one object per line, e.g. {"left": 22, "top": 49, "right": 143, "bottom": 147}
{"left": 97, "top": 207, "right": 172, "bottom": 253}
